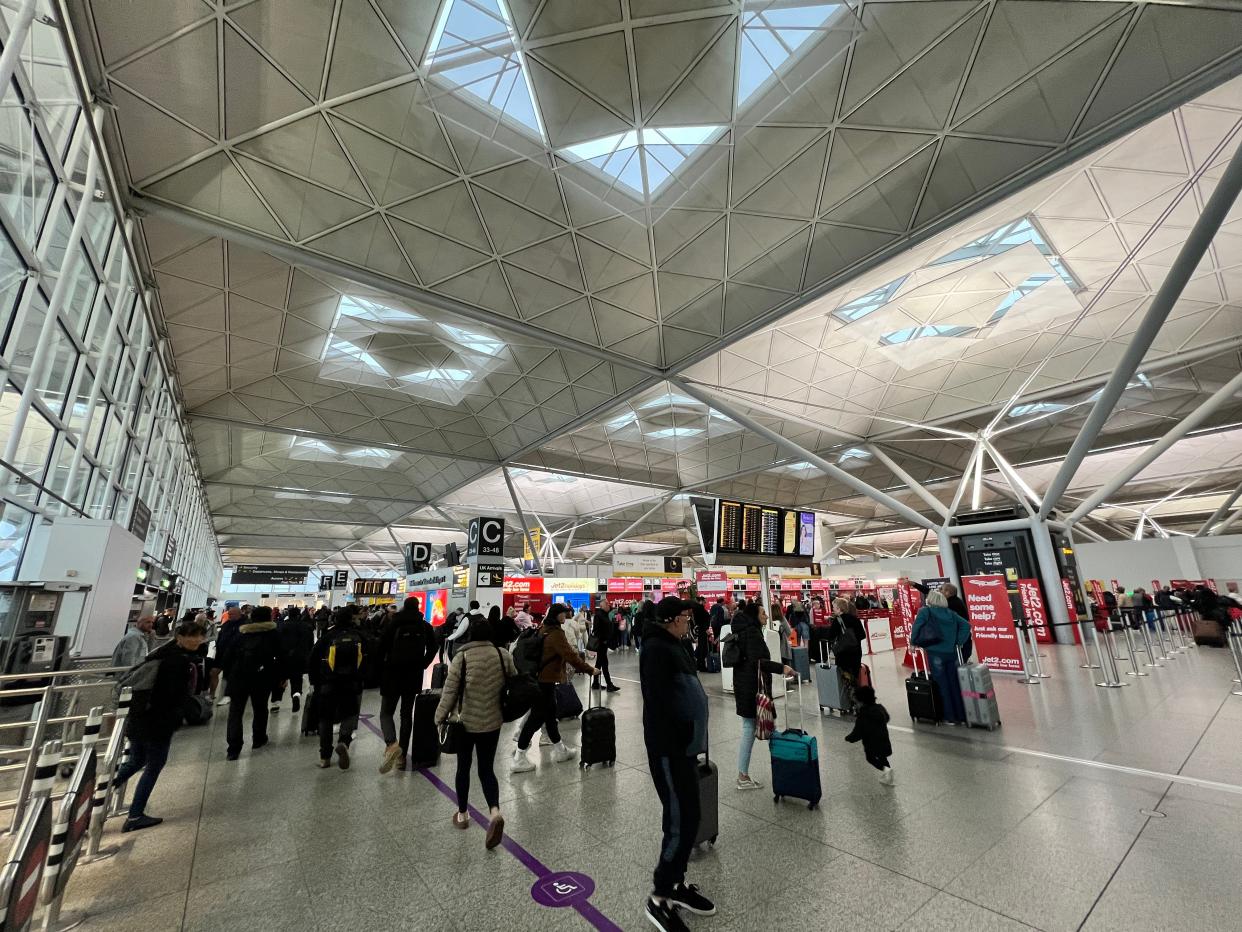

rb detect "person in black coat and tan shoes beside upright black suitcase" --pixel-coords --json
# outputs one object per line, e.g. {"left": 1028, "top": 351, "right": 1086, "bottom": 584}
{"left": 379, "top": 595, "right": 436, "bottom": 773}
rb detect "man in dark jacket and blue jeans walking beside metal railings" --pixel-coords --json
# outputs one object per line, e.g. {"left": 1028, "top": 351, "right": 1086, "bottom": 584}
{"left": 116, "top": 620, "right": 207, "bottom": 831}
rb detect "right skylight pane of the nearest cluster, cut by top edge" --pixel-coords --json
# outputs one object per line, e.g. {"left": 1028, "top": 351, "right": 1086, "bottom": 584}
{"left": 738, "top": 0, "right": 843, "bottom": 107}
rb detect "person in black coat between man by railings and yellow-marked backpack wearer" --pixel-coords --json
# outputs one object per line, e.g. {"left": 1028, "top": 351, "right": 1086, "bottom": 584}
{"left": 216, "top": 605, "right": 284, "bottom": 761}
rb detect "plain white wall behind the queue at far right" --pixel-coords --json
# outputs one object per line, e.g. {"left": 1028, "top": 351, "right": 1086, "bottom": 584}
{"left": 1076, "top": 534, "right": 1242, "bottom": 589}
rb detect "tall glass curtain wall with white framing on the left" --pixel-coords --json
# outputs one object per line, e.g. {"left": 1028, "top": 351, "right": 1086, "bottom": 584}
{"left": 0, "top": 0, "right": 221, "bottom": 606}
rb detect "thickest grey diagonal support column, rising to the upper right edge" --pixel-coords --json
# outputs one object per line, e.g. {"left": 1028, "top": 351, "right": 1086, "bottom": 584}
{"left": 1040, "top": 134, "right": 1242, "bottom": 518}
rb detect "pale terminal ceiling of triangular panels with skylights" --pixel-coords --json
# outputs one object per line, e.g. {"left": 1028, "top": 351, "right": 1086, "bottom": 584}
{"left": 60, "top": 0, "right": 1242, "bottom": 565}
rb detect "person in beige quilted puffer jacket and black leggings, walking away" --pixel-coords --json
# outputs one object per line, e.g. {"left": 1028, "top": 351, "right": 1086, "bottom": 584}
{"left": 436, "top": 618, "right": 517, "bottom": 849}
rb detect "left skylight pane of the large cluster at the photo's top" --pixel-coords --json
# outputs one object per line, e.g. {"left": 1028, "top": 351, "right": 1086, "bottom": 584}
{"left": 427, "top": 0, "right": 544, "bottom": 139}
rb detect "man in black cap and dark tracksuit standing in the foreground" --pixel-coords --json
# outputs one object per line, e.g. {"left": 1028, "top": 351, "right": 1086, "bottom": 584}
{"left": 638, "top": 595, "right": 715, "bottom": 932}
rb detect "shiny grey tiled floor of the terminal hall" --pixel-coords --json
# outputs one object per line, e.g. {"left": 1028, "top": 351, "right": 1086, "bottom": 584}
{"left": 48, "top": 646, "right": 1242, "bottom": 932}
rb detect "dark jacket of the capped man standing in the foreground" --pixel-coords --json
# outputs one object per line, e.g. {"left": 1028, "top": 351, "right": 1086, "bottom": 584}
{"left": 638, "top": 624, "right": 708, "bottom": 758}
